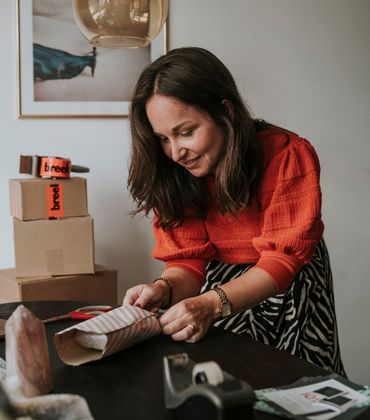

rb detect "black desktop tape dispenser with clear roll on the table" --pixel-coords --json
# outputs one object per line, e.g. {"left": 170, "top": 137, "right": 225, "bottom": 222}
{"left": 163, "top": 353, "right": 255, "bottom": 420}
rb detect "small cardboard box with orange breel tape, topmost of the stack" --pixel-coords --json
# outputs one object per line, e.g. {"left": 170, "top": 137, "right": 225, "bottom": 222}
{"left": 9, "top": 177, "right": 88, "bottom": 220}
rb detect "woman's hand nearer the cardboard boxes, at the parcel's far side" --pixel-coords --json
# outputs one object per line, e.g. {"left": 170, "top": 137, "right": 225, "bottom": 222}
{"left": 122, "top": 281, "right": 168, "bottom": 312}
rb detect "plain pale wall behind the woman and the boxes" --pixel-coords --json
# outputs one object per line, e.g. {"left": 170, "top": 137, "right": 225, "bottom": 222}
{"left": 0, "top": 0, "right": 370, "bottom": 384}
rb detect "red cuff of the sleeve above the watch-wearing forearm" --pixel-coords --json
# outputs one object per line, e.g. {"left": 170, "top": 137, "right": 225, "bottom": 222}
{"left": 256, "top": 252, "right": 304, "bottom": 293}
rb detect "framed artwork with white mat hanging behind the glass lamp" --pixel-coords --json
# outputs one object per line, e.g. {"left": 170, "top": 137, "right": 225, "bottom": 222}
{"left": 17, "top": 0, "right": 167, "bottom": 118}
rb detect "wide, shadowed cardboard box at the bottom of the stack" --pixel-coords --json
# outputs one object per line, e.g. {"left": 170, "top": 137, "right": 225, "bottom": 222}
{"left": 0, "top": 265, "right": 117, "bottom": 305}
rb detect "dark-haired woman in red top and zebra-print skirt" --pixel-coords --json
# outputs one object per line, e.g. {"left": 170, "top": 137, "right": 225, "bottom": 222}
{"left": 123, "top": 48, "right": 344, "bottom": 374}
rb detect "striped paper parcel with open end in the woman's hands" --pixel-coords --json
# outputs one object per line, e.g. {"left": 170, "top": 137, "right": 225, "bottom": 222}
{"left": 54, "top": 305, "right": 161, "bottom": 366}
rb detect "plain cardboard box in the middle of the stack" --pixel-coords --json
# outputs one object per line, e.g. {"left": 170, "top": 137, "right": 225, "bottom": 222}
{"left": 13, "top": 216, "right": 94, "bottom": 277}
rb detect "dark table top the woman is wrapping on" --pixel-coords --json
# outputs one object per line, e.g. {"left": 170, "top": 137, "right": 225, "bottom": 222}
{"left": 0, "top": 302, "right": 370, "bottom": 420}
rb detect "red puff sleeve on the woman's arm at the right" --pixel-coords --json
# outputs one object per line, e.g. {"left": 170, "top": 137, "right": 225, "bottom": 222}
{"left": 253, "top": 137, "right": 324, "bottom": 292}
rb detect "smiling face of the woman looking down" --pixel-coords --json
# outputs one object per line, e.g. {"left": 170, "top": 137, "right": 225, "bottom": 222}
{"left": 146, "top": 94, "right": 225, "bottom": 177}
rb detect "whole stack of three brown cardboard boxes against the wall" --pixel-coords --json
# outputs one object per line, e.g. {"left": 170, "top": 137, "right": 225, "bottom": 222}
{"left": 0, "top": 177, "right": 117, "bottom": 304}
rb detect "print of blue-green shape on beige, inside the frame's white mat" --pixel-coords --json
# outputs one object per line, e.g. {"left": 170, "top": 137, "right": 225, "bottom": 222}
{"left": 32, "top": 0, "right": 150, "bottom": 101}
